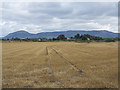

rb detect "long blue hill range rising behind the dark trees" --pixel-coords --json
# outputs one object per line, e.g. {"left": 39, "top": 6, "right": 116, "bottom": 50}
{"left": 4, "top": 30, "right": 120, "bottom": 39}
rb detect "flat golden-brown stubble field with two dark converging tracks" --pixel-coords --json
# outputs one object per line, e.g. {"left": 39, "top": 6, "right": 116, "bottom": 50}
{"left": 2, "top": 42, "right": 118, "bottom": 88}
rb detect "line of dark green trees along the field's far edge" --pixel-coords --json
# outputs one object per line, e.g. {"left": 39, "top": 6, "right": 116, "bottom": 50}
{"left": 2, "top": 34, "right": 120, "bottom": 42}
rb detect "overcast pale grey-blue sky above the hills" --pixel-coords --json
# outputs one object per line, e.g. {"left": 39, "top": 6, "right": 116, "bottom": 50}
{"left": 0, "top": 2, "right": 118, "bottom": 36}
